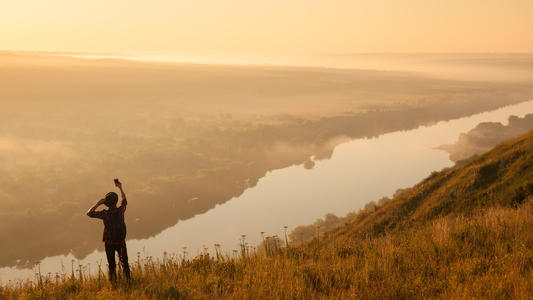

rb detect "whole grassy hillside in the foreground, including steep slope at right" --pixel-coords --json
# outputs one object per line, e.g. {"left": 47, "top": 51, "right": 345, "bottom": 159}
{"left": 0, "top": 132, "right": 533, "bottom": 299}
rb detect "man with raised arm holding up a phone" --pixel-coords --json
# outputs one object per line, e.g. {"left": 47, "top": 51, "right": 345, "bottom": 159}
{"left": 87, "top": 179, "right": 130, "bottom": 282}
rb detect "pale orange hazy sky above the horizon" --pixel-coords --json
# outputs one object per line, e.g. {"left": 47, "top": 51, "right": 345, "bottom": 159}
{"left": 0, "top": 0, "right": 533, "bottom": 55}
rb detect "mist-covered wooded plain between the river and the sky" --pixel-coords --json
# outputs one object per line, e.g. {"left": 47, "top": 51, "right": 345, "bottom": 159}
{"left": 0, "top": 53, "right": 533, "bottom": 266}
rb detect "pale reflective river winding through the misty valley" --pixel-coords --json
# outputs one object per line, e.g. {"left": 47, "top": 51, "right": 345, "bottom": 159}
{"left": 0, "top": 100, "right": 533, "bottom": 284}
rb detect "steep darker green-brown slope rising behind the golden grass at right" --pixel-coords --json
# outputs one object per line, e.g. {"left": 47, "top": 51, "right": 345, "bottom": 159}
{"left": 336, "top": 131, "right": 533, "bottom": 239}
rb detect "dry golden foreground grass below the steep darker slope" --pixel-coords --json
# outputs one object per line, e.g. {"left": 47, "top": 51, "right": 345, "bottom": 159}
{"left": 0, "top": 204, "right": 533, "bottom": 299}
